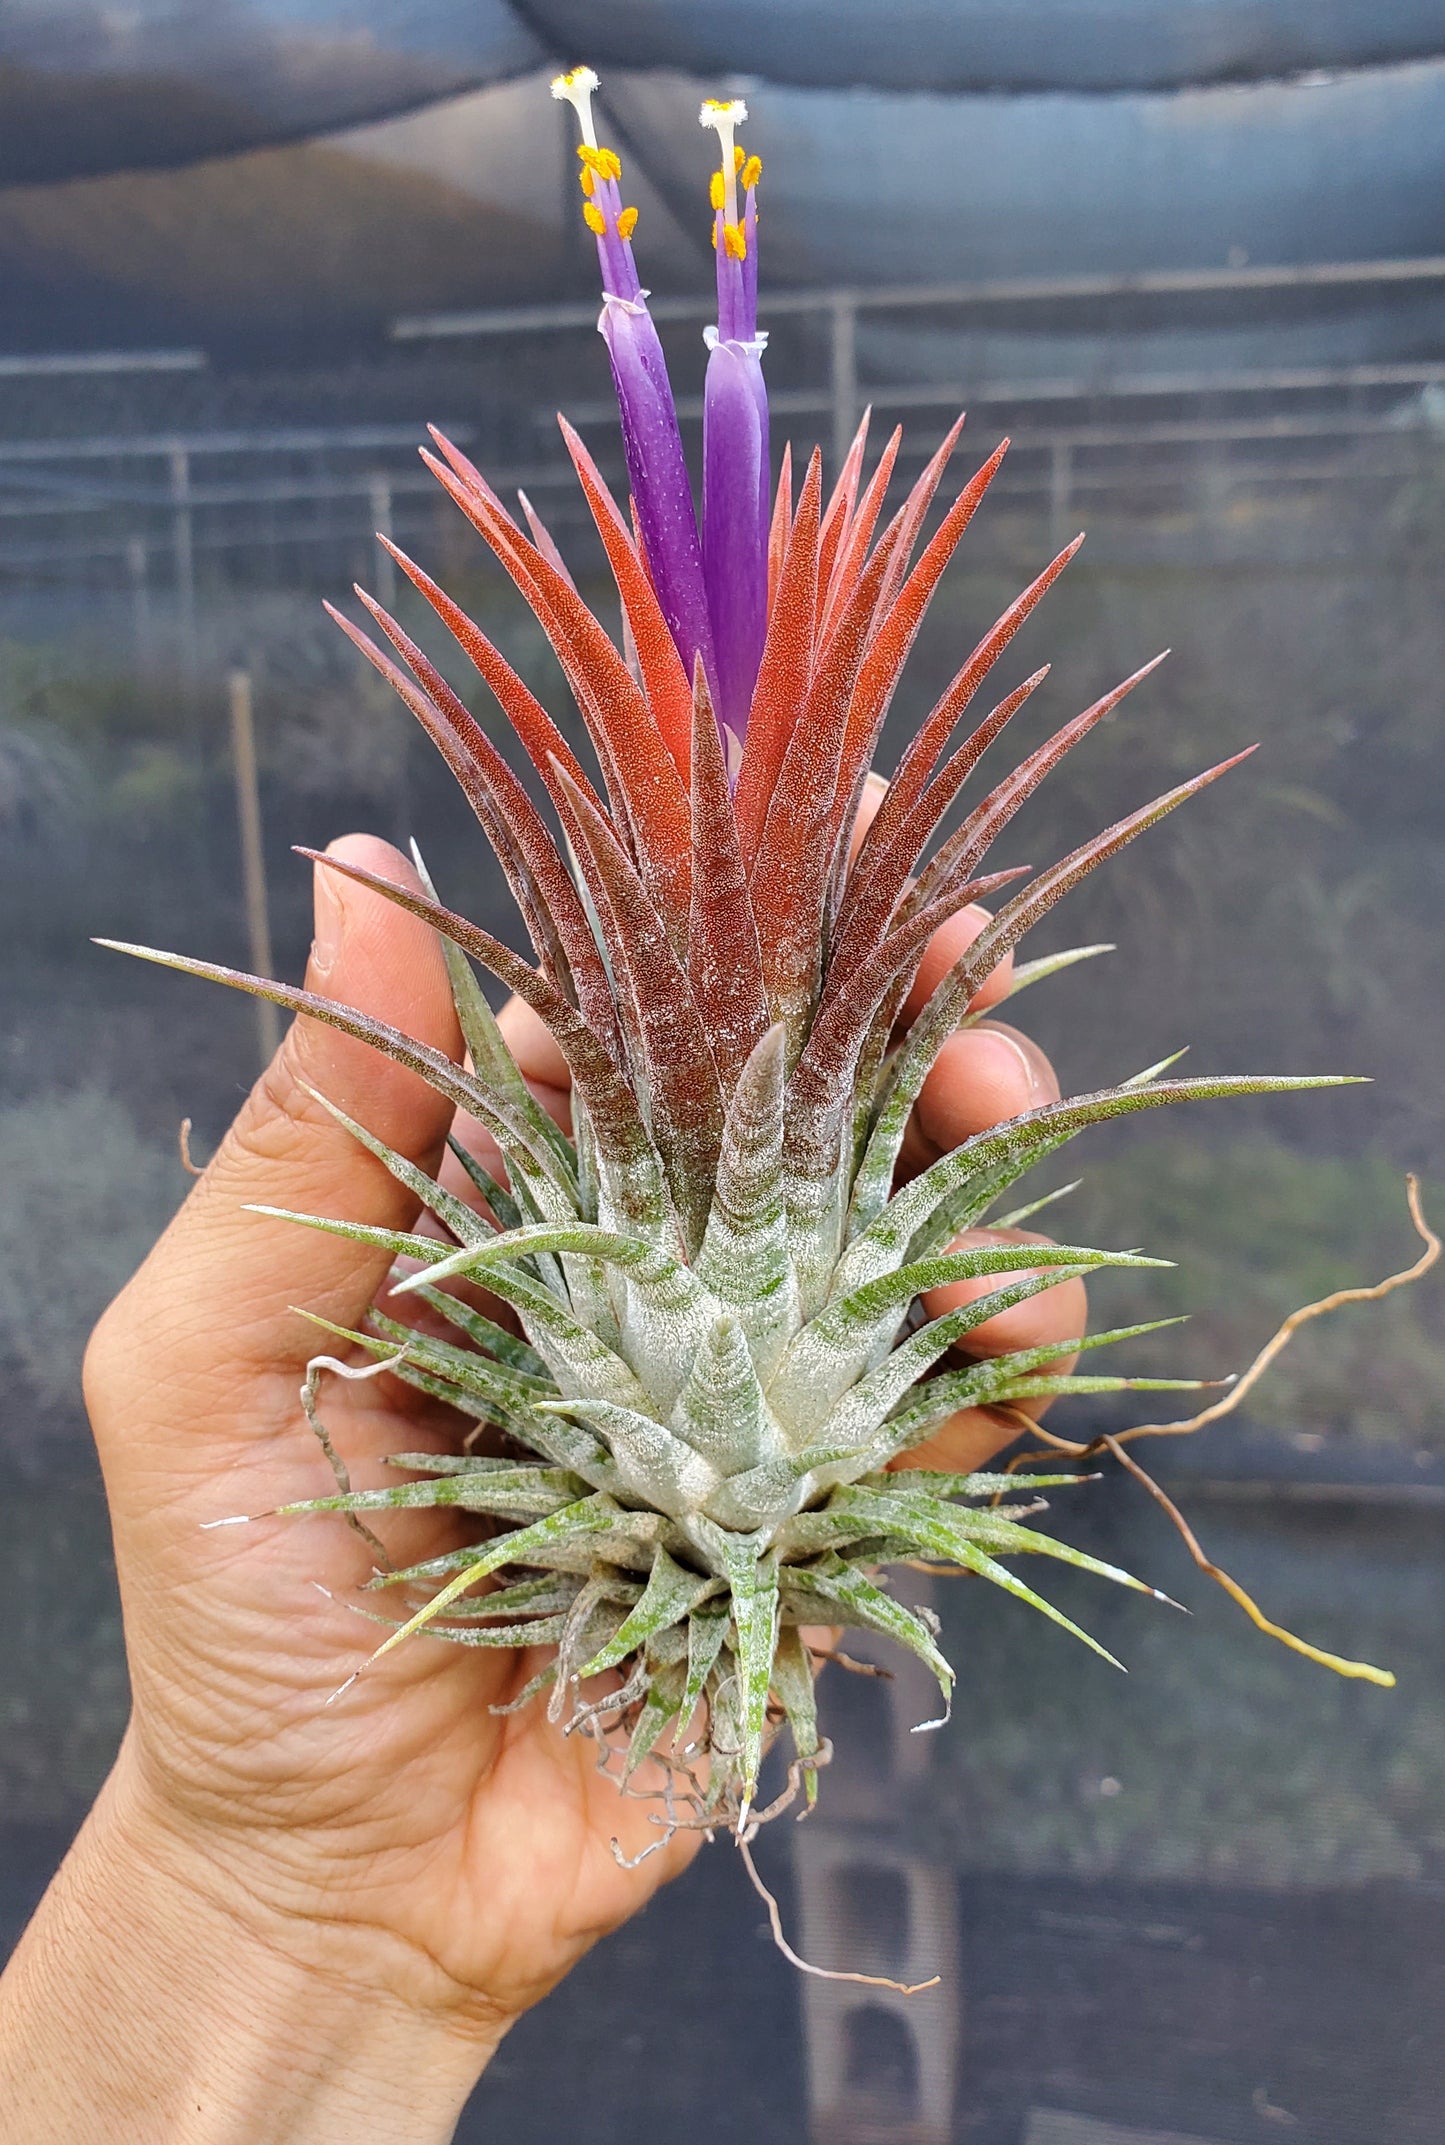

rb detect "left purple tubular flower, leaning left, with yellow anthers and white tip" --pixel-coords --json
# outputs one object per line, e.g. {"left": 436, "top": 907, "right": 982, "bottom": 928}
{"left": 551, "top": 66, "right": 718, "bottom": 693}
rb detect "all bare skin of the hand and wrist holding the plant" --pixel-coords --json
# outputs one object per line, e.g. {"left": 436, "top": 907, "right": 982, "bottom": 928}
{"left": 0, "top": 793, "right": 1085, "bottom": 2145}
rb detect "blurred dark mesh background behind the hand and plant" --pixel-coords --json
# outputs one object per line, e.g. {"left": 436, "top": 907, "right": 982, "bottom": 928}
{"left": 0, "top": 0, "right": 1445, "bottom": 2145}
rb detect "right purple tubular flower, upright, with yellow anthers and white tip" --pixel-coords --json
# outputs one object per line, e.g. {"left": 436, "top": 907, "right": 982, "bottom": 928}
{"left": 701, "top": 99, "right": 770, "bottom": 761}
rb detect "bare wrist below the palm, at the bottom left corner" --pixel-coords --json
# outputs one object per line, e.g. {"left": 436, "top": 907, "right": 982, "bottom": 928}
{"left": 0, "top": 1757, "right": 510, "bottom": 2145}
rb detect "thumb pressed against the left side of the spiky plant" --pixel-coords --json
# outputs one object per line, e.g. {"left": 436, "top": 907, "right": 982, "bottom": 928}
{"left": 86, "top": 834, "right": 461, "bottom": 1448}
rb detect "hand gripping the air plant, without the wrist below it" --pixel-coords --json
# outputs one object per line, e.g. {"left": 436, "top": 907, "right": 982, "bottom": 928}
{"left": 78, "top": 839, "right": 1067, "bottom": 2023}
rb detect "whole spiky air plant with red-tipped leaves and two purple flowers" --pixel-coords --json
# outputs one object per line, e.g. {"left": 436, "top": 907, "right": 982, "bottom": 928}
{"left": 98, "top": 69, "right": 1372, "bottom": 1838}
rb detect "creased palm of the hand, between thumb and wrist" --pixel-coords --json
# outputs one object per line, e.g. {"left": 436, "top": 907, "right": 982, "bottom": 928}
{"left": 92, "top": 1269, "right": 695, "bottom": 2016}
